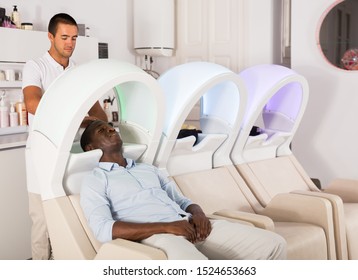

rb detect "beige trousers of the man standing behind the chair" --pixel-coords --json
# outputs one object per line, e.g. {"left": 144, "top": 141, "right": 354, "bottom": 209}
{"left": 29, "top": 193, "right": 51, "bottom": 260}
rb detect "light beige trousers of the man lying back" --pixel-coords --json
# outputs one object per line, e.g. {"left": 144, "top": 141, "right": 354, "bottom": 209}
{"left": 142, "top": 220, "right": 286, "bottom": 260}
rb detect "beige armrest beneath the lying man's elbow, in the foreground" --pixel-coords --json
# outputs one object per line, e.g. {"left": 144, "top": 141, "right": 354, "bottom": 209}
{"left": 95, "top": 238, "right": 167, "bottom": 260}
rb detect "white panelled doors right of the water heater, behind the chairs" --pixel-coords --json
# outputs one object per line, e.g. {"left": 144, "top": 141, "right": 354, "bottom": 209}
{"left": 176, "top": 0, "right": 280, "bottom": 72}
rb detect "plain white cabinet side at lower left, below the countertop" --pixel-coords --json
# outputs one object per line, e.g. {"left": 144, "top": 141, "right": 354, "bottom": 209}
{"left": 0, "top": 147, "right": 31, "bottom": 260}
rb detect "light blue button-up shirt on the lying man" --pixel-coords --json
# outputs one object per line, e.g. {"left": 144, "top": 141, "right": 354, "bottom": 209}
{"left": 81, "top": 159, "right": 192, "bottom": 242}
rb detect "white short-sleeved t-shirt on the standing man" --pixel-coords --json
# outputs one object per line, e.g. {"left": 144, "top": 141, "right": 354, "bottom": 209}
{"left": 22, "top": 52, "right": 75, "bottom": 126}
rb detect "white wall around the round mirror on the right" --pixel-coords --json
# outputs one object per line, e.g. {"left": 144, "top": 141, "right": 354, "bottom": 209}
{"left": 292, "top": 0, "right": 358, "bottom": 186}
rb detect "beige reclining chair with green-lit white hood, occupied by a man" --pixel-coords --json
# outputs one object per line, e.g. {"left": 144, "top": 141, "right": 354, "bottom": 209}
{"left": 26, "top": 60, "right": 166, "bottom": 259}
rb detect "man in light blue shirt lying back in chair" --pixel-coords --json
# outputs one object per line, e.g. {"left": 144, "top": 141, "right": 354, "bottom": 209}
{"left": 81, "top": 121, "right": 286, "bottom": 260}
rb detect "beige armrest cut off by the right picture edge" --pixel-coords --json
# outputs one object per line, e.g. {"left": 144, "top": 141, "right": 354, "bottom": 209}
{"left": 323, "top": 179, "right": 358, "bottom": 203}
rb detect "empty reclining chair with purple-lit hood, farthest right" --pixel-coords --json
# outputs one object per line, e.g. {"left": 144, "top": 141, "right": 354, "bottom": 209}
{"left": 232, "top": 65, "right": 358, "bottom": 259}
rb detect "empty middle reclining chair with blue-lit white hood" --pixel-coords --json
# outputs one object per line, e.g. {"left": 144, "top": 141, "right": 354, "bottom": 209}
{"left": 154, "top": 62, "right": 336, "bottom": 259}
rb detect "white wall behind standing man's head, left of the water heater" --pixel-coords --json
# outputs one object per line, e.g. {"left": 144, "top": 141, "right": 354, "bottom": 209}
{"left": 0, "top": 0, "right": 134, "bottom": 63}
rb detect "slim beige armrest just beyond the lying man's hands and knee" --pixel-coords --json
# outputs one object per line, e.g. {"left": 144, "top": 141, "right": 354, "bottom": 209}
{"left": 210, "top": 209, "right": 275, "bottom": 231}
